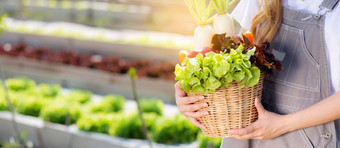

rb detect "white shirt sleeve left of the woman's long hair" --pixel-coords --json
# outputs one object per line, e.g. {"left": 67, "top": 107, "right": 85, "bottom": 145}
{"left": 231, "top": 0, "right": 260, "bottom": 30}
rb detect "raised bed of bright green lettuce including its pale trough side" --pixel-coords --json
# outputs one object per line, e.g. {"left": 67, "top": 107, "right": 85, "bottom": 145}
{"left": 0, "top": 78, "right": 223, "bottom": 148}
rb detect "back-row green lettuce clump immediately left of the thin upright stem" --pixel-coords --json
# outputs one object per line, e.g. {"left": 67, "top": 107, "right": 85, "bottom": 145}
{"left": 87, "top": 95, "right": 125, "bottom": 113}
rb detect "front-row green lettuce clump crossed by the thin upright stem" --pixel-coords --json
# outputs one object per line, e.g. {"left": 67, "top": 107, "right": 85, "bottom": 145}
{"left": 109, "top": 113, "right": 159, "bottom": 139}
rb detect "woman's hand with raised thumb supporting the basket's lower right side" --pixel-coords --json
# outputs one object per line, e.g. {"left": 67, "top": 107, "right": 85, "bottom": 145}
{"left": 229, "top": 98, "right": 289, "bottom": 140}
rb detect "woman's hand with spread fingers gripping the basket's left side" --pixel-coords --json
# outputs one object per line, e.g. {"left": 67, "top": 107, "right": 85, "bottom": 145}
{"left": 175, "top": 82, "right": 209, "bottom": 129}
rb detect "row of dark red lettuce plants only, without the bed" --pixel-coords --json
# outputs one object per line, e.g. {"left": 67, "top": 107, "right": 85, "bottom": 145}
{"left": 0, "top": 43, "right": 175, "bottom": 80}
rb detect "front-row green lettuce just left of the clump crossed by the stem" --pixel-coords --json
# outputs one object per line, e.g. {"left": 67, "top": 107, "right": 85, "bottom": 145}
{"left": 77, "top": 113, "right": 121, "bottom": 134}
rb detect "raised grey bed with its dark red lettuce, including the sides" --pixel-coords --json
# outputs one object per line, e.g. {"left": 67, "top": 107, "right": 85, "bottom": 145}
{"left": 0, "top": 32, "right": 181, "bottom": 103}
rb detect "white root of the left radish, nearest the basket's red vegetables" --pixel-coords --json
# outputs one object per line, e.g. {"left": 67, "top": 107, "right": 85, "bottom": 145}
{"left": 194, "top": 25, "right": 214, "bottom": 51}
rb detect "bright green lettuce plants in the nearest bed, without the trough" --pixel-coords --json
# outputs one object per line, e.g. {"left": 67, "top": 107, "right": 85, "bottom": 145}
{"left": 0, "top": 77, "right": 221, "bottom": 148}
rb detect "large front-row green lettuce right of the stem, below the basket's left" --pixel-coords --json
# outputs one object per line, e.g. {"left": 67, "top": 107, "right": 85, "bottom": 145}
{"left": 152, "top": 115, "right": 199, "bottom": 144}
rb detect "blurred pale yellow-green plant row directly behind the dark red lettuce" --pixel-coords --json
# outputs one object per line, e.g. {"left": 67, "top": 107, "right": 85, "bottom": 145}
{"left": 5, "top": 18, "right": 193, "bottom": 49}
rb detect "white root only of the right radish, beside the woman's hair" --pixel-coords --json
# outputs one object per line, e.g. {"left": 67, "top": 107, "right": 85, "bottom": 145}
{"left": 213, "top": 13, "right": 235, "bottom": 36}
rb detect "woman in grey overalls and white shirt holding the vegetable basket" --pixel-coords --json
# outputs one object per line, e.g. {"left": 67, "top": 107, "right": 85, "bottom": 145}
{"left": 175, "top": 0, "right": 340, "bottom": 148}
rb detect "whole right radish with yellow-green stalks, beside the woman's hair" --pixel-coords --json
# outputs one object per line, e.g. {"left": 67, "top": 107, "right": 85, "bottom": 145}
{"left": 212, "top": 0, "right": 236, "bottom": 36}
